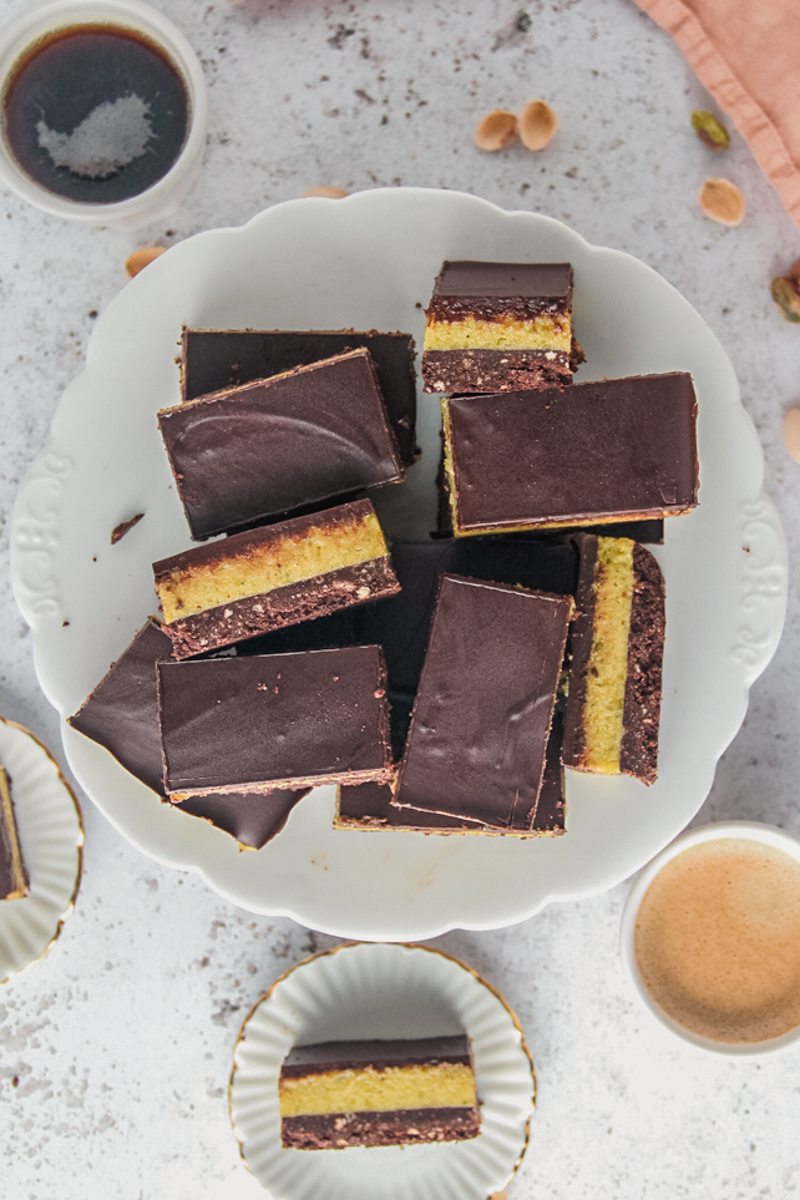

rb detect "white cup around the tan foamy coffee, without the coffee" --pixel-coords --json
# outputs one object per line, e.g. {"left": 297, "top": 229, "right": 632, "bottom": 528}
{"left": 620, "top": 821, "right": 800, "bottom": 1058}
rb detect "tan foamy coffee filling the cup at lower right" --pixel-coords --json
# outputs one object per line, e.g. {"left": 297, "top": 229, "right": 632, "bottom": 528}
{"left": 633, "top": 838, "right": 800, "bottom": 1043}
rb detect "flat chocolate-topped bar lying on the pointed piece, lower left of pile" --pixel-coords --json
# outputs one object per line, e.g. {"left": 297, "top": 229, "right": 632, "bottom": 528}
{"left": 157, "top": 646, "right": 392, "bottom": 803}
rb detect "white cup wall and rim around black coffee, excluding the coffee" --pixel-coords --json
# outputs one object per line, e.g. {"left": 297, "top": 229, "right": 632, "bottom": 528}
{"left": 0, "top": 0, "right": 207, "bottom": 226}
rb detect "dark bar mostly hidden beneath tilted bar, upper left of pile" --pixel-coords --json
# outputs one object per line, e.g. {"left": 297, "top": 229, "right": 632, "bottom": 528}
{"left": 181, "top": 329, "right": 416, "bottom": 466}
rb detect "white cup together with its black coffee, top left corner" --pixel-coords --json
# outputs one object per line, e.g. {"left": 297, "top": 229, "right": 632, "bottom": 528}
{"left": 0, "top": 0, "right": 207, "bottom": 226}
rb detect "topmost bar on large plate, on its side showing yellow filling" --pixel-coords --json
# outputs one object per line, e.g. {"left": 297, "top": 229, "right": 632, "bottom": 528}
{"left": 422, "top": 262, "right": 583, "bottom": 394}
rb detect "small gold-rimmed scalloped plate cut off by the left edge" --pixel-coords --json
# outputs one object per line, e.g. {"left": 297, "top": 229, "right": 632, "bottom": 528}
{"left": 0, "top": 716, "right": 84, "bottom": 983}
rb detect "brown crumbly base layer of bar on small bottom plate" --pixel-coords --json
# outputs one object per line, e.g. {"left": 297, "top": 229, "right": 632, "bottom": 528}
{"left": 281, "top": 1108, "right": 481, "bottom": 1150}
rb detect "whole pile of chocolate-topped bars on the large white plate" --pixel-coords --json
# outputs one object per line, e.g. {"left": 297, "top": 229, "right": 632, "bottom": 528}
{"left": 71, "top": 262, "right": 698, "bottom": 848}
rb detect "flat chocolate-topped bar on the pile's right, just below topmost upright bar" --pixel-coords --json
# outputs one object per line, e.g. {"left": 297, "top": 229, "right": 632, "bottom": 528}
{"left": 443, "top": 372, "right": 698, "bottom": 536}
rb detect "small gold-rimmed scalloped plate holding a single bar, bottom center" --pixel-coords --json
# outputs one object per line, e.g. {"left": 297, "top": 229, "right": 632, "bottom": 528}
{"left": 228, "top": 944, "right": 536, "bottom": 1200}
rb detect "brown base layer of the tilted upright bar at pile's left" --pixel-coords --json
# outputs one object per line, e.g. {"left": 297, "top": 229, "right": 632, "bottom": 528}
{"left": 163, "top": 556, "right": 399, "bottom": 659}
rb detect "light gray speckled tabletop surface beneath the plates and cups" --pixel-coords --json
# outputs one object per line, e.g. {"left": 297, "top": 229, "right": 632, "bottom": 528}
{"left": 0, "top": 0, "right": 800, "bottom": 1200}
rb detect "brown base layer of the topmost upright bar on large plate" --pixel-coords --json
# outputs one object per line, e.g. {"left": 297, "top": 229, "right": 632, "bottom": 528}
{"left": 422, "top": 349, "right": 572, "bottom": 395}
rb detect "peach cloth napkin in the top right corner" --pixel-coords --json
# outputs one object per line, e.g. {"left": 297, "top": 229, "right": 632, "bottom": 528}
{"left": 636, "top": 0, "right": 800, "bottom": 224}
